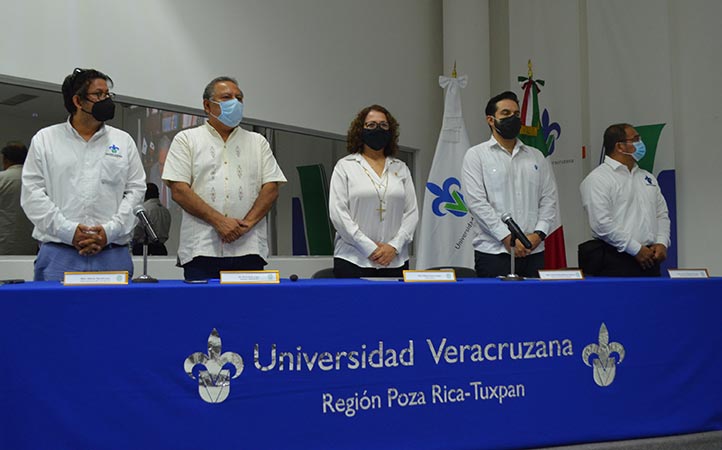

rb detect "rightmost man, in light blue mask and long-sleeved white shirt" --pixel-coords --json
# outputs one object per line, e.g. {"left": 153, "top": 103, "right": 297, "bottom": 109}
{"left": 579, "top": 123, "right": 670, "bottom": 277}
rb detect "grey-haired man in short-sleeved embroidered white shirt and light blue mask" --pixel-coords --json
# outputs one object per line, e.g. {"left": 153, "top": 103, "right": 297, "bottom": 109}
{"left": 162, "top": 77, "right": 286, "bottom": 280}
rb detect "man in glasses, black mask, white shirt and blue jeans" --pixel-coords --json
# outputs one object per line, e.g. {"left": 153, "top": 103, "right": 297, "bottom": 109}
{"left": 21, "top": 69, "right": 145, "bottom": 281}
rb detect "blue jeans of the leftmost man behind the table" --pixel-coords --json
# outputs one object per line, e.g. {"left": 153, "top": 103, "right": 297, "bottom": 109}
{"left": 34, "top": 242, "right": 133, "bottom": 281}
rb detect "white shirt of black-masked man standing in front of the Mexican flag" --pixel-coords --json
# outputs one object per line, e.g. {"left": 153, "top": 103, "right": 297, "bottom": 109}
{"left": 461, "top": 136, "right": 559, "bottom": 254}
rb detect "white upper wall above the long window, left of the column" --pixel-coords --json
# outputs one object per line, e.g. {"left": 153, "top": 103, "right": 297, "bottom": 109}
{"left": 0, "top": 0, "right": 443, "bottom": 181}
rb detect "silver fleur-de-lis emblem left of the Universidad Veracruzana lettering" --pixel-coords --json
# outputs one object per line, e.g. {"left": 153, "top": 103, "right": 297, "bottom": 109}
{"left": 183, "top": 328, "right": 243, "bottom": 403}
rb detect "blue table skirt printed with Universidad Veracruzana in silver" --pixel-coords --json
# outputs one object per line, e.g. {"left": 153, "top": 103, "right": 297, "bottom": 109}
{"left": 0, "top": 279, "right": 722, "bottom": 450}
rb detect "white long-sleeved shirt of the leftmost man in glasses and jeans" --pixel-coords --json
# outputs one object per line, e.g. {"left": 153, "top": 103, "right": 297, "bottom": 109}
{"left": 21, "top": 120, "right": 145, "bottom": 245}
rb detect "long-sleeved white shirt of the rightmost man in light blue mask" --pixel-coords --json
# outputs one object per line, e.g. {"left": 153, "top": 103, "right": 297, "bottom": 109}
{"left": 580, "top": 156, "right": 670, "bottom": 256}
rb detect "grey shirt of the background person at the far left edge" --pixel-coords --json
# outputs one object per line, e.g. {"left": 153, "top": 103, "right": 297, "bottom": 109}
{"left": 0, "top": 164, "right": 38, "bottom": 255}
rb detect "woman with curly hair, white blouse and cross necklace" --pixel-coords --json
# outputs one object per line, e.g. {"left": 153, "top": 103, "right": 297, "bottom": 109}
{"left": 329, "top": 105, "right": 419, "bottom": 278}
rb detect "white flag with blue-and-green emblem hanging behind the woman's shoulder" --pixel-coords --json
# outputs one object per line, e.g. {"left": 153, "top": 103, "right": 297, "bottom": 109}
{"left": 416, "top": 75, "right": 475, "bottom": 269}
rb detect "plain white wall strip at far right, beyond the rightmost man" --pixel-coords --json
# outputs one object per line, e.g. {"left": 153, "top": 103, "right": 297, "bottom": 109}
{"left": 669, "top": 0, "right": 722, "bottom": 276}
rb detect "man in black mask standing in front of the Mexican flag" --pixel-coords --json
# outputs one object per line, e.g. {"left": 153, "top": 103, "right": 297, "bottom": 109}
{"left": 461, "top": 91, "right": 558, "bottom": 277}
